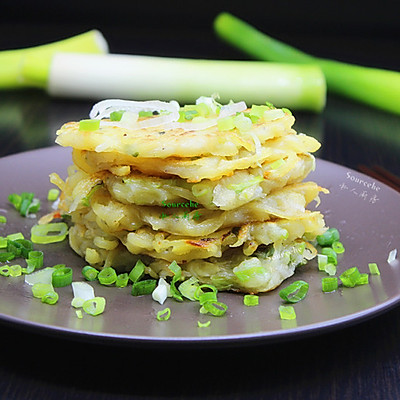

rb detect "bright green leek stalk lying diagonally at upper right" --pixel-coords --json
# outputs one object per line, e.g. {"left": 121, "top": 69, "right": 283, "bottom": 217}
{"left": 214, "top": 13, "right": 400, "bottom": 114}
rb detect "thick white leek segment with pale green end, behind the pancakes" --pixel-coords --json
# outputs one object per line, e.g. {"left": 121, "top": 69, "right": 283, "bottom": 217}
{"left": 48, "top": 53, "right": 326, "bottom": 111}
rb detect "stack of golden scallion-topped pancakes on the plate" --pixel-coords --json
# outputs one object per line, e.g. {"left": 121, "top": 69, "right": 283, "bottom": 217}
{"left": 51, "top": 97, "right": 327, "bottom": 293}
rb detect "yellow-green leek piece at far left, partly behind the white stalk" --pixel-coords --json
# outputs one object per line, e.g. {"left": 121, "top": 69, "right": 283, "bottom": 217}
{"left": 0, "top": 30, "right": 108, "bottom": 89}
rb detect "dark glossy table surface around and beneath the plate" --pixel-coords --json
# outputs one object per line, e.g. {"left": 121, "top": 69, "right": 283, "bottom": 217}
{"left": 0, "top": 15, "right": 400, "bottom": 400}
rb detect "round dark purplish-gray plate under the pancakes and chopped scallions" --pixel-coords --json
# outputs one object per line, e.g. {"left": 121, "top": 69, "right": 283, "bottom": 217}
{"left": 0, "top": 147, "right": 400, "bottom": 346}
